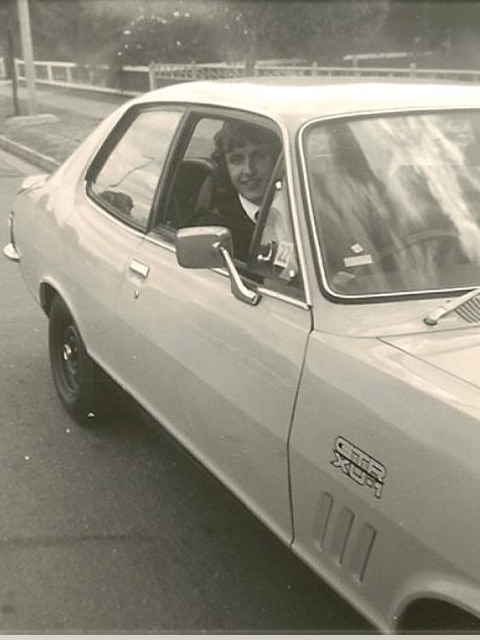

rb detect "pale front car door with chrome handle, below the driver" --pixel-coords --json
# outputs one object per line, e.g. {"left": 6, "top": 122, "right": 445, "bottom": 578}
{"left": 115, "top": 112, "right": 311, "bottom": 542}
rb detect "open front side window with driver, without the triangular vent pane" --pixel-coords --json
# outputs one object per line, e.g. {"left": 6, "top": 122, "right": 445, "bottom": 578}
{"left": 158, "top": 117, "right": 281, "bottom": 250}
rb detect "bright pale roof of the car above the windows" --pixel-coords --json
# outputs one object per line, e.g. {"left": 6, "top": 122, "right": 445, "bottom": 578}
{"left": 134, "top": 76, "right": 480, "bottom": 126}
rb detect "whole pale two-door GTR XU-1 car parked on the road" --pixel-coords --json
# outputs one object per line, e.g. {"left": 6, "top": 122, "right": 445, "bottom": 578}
{"left": 4, "top": 77, "right": 480, "bottom": 633}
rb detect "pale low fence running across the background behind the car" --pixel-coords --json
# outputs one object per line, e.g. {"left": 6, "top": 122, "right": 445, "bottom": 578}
{"left": 0, "top": 58, "right": 480, "bottom": 95}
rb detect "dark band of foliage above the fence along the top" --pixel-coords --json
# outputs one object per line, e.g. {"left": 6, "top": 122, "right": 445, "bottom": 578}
{"left": 0, "top": 0, "right": 480, "bottom": 67}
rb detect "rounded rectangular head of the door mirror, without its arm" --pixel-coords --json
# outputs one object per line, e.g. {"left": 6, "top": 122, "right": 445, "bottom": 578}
{"left": 175, "top": 227, "right": 233, "bottom": 269}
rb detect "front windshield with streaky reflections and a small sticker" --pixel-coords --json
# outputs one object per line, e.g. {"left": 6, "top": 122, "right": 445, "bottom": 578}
{"left": 303, "top": 111, "right": 480, "bottom": 296}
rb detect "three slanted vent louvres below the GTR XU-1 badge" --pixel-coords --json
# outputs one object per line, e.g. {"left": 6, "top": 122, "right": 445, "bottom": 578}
{"left": 313, "top": 491, "right": 377, "bottom": 582}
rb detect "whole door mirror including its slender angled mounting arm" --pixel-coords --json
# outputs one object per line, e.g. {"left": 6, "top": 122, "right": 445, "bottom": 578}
{"left": 175, "top": 227, "right": 260, "bottom": 305}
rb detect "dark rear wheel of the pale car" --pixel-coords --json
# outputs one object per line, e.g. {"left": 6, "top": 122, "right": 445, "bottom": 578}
{"left": 48, "top": 296, "right": 98, "bottom": 420}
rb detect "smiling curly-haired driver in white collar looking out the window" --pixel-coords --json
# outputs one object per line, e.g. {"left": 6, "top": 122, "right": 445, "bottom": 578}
{"left": 197, "top": 121, "right": 281, "bottom": 262}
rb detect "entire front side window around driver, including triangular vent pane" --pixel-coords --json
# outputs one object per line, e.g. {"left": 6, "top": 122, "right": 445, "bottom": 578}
{"left": 156, "top": 117, "right": 303, "bottom": 297}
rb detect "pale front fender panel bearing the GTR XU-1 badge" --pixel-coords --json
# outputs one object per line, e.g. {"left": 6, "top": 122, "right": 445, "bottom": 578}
{"left": 290, "top": 332, "right": 480, "bottom": 628}
